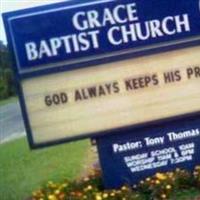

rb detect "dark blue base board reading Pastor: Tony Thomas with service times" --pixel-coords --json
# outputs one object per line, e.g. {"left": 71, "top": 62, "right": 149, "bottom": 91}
{"left": 96, "top": 118, "right": 200, "bottom": 188}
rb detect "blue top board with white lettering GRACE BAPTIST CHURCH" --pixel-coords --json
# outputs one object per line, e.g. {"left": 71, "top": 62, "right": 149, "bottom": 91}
{"left": 3, "top": 0, "right": 200, "bottom": 77}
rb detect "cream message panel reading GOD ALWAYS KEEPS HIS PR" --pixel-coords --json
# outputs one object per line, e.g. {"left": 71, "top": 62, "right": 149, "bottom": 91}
{"left": 22, "top": 47, "right": 200, "bottom": 144}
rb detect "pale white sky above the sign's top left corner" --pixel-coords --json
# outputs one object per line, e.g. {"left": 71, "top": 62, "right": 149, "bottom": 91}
{"left": 0, "top": 0, "right": 64, "bottom": 44}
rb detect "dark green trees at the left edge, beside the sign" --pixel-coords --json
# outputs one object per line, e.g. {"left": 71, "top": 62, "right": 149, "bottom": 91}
{"left": 0, "top": 41, "right": 15, "bottom": 100}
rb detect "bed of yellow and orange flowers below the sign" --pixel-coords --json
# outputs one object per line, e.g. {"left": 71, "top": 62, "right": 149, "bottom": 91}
{"left": 31, "top": 166, "right": 200, "bottom": 200}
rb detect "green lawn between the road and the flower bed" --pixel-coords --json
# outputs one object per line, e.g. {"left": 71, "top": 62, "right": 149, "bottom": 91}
{"left": 0, "top": 139, "right": 89, "bottom": 200}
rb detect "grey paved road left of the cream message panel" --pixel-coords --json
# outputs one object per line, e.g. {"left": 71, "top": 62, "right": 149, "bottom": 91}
{"left": 0, "top": 102, "right": 25, "bottom": 143}
